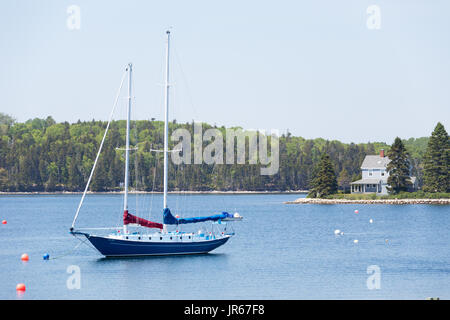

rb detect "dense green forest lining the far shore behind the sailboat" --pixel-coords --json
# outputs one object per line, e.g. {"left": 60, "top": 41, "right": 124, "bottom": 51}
{"left": 0, "top": 113, "right": 429, "bottom": 192}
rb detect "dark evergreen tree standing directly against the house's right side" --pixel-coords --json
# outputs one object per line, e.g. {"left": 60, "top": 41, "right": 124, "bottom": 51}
{"left": 386, "top": 137, "right": 411, "bottom": 194}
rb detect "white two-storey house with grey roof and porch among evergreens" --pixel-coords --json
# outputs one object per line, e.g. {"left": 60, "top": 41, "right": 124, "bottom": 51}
{"left": 350, "top": 149, "right": 417, "bottom": 195}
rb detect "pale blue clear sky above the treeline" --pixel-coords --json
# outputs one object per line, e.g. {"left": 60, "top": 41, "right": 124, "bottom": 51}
{"left": 0, "top": 0, "right": 450, "bottom": 143}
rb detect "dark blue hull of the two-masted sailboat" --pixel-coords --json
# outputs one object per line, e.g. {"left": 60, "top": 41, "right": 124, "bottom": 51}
{"left": 84, "top": 234, "right": 229, "bottom": 257}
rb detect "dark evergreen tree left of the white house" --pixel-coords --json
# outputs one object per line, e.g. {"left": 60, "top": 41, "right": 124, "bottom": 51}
{"left": 308, "top": 153, "right": 338, "bottom": 198}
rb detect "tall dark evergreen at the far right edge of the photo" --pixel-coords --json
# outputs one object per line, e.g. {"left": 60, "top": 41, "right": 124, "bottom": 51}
{"left": 423, "top": 122, "right": 450, "bottom": 192}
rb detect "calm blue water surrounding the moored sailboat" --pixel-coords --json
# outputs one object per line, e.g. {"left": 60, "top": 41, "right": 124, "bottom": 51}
{"left": 0, "top": 195, "right": 450, "bottom": 299}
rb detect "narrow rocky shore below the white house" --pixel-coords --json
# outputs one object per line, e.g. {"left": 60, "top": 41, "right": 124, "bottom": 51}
{"left": 284, "top": 198, "right": 450, "bottom": 204}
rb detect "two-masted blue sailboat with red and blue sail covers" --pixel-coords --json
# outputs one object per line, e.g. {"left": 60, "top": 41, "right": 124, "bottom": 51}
{"left": 70, "top": 31, "right": 243, "bottom": 257}
